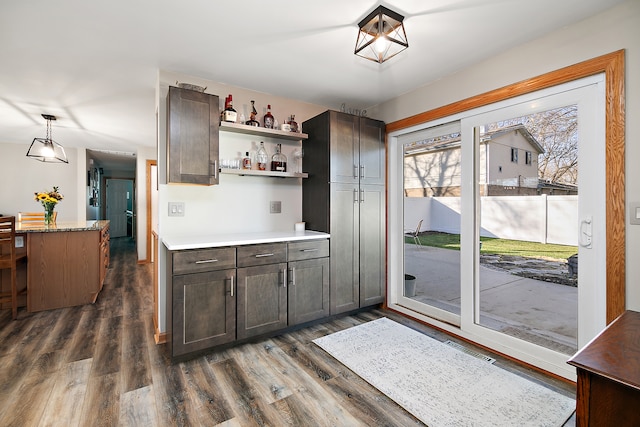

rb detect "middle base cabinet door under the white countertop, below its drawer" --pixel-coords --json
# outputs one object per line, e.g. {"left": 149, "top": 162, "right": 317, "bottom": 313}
{"left": 237, "top": 263, "right": 287, "bottom": 339}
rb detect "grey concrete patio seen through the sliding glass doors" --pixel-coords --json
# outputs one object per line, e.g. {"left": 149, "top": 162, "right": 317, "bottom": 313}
{"left": 405, "top": 243, "right": 578, "bottom": 355}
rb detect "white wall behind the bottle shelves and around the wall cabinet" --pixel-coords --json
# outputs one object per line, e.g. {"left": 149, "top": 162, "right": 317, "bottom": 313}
{"left": 156, "top": 70, "right": 327, "bottom": 332}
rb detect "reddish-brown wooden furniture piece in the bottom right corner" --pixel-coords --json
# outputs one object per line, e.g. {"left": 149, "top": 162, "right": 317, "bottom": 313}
{"left": 568, "top": 311, "right": 640, "bottom": 427}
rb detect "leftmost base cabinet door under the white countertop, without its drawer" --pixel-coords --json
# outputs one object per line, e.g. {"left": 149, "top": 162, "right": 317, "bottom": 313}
{"left": 171, "top": 270, "right": 236, "bottom": 357}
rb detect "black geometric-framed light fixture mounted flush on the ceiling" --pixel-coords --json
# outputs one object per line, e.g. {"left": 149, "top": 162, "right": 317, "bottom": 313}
{"left": 354, "top": 6, "right": 409, "bottom": 64}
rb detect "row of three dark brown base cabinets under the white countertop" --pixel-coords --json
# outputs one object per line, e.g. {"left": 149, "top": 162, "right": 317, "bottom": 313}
{"left": 166, "top": 239, "right": 329, "bottom": 359}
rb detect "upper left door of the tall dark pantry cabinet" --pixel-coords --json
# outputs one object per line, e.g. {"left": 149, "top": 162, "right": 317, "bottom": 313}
{"left": 329, "top": 111, "right": 360, "bottom": 184}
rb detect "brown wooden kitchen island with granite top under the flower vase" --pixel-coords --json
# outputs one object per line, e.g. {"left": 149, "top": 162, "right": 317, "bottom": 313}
{"left": 16, "top": 221, "right": 109, "bottom": 312}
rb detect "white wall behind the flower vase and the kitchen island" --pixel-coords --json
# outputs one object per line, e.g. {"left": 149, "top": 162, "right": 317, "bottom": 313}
{"left": 0, "top": 143, "right": 82, "bottom": 221}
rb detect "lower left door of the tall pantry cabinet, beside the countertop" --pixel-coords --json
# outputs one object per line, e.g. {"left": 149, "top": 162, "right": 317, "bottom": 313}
{"left": 329, "top": 183, "right": 360, "bottom": 315}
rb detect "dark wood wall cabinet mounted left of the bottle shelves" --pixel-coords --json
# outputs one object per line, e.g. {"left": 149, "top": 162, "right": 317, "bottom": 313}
{"left": 167, "top": 86, "right": 220, "bottom": 185}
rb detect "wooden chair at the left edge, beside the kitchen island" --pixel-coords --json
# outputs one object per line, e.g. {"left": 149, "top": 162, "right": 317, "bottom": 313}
{"left": 0, "top": 216, "right": 27, "bottom": 319}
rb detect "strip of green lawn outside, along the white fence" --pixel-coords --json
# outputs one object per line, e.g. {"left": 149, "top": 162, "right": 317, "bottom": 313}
{"left": 405, "top": 231, "right": 578, "bottom": 259}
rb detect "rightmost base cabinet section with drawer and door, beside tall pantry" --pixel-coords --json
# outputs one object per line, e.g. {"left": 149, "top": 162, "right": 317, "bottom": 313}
{"left": 288, "top": 240, "right": 329, "bottom": 326}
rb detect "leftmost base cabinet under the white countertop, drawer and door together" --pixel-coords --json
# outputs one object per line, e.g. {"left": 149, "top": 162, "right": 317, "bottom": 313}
{"left": 167, "top": 248, "right": 236, "bottom": 358}
